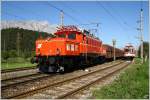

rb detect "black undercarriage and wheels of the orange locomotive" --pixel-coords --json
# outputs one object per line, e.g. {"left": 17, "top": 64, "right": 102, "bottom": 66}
{"left": 31, "top": 54, "right": 105, "bottom": 73}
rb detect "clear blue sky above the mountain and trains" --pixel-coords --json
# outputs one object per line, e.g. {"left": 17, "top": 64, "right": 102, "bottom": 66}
{"left": 1, "top": 1, "right": 149, "bottom": 48}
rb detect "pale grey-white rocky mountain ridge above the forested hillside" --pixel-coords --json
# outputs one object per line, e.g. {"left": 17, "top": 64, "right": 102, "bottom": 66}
{"left": 1, "top": 20, "right": 58, "bottom": 34}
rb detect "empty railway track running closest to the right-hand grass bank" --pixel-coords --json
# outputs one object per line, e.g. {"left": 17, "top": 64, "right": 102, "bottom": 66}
{"left": 27, "top": 63, "right": 128, "bottom": 99}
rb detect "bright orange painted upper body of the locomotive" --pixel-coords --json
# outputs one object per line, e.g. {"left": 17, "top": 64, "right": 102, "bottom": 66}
{"left": 36, "top": 25, "right": 105, "bottom": 56}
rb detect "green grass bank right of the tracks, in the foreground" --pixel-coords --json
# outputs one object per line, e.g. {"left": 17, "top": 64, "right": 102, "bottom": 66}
{"left": 93, "top": 58, "right": 149, "bottom": 99}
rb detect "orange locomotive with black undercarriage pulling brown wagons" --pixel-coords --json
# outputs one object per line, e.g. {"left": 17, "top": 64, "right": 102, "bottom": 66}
{"left": 31, "top": 26, "right": 131, "bottom": 72}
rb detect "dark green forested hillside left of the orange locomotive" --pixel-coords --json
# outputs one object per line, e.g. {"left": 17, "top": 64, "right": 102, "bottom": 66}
{"left": 1, "top": 28, "right": 53, "bottom": 59}
